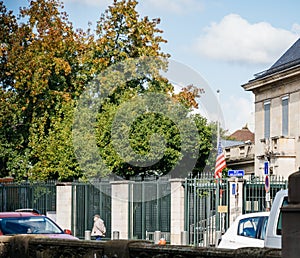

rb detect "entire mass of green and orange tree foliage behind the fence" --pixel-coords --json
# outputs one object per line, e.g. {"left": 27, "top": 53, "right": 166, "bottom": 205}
{"left": 0, "top": 0, "right": 219, "bottom": 180}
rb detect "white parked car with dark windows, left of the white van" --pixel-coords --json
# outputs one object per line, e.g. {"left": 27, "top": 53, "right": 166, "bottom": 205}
{"left": 218, "top": 212, "right": 270, "bottom": 249}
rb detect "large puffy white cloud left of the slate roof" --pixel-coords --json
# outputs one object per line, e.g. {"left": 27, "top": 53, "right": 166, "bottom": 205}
{"left": 194, "top": 14, "right": 300, "bottom": 64}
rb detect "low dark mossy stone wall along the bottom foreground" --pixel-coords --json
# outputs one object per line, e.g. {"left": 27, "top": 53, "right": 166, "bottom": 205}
{"left": 0, "top": 235, "right": 281, "bottom": 258}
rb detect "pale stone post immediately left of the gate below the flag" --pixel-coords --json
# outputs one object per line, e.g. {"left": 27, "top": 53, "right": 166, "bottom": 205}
{"left": 170, "top": 178, "right": 184, "bottom": 245}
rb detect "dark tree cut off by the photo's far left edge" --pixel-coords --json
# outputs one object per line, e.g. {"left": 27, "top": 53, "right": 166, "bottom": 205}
{"left": 0, "top": 2, "right": 26, "bottom": 176}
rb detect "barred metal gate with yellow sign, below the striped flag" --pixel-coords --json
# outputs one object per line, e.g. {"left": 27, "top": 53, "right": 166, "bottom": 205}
{"left": 185, "top": 177, "right": 229, "bottom": 246}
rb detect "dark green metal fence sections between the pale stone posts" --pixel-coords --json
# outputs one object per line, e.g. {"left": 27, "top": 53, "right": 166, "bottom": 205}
{"left": 0, "top": 176, "right": 288, "bottom": 246}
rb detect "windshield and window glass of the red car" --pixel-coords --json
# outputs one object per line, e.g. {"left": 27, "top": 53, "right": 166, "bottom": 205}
{"left": 0, "top": 216, "right": 63, "bottom": 235}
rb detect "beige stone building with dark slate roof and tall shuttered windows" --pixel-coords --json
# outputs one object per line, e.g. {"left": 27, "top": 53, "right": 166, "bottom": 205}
{"left": 242, "top": 39, "right": 300, "bottom": 178}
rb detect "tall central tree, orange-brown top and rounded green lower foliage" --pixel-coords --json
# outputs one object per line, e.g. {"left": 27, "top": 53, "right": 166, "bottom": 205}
{"left": 75, "top": 0, "right": 211, "bottom": 178}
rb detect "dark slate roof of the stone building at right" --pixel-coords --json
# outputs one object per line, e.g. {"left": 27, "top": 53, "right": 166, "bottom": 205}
{"left": 254, "top": 38, "right": 300, "bottom": 79}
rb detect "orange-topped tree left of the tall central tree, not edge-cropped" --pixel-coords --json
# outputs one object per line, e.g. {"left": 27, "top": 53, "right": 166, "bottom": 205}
{"left": 2, "top": 0, "right": 85, "bottom": 180}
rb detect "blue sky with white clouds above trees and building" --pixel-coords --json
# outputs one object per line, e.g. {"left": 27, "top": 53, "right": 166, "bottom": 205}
{"left": 4, "top": 0, "right": 300, "bottom": 134}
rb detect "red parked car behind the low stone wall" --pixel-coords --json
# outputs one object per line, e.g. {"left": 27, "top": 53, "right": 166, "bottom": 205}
{"left": 0, "top": 210, "right": 78, "bottom": 240}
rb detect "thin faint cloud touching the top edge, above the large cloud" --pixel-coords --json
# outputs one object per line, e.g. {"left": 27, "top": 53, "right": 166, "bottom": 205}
{"left": 141, "top": 0, "right": 204, "bottom": 15}
